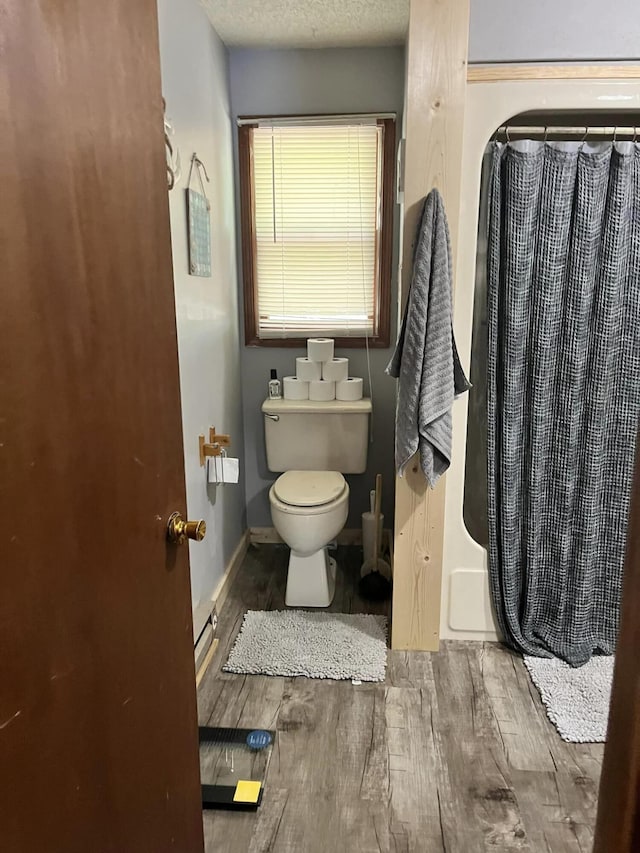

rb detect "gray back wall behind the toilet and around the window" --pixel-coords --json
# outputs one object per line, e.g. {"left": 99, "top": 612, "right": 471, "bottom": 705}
{"left": 230, "top": 48, "right": 404, "bottom": 527}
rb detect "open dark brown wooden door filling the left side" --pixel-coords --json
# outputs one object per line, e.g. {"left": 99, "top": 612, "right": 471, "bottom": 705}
{"left": 0, "top": 0, "right": 202, "bottom": 853}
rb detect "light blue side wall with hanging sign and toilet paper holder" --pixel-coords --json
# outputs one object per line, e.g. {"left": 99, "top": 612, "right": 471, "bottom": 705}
{"left": 158, "top": 0, "right": 245, "bottom": 607}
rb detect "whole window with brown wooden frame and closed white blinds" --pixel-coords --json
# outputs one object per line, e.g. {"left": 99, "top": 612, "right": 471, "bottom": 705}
{"left": 239, "top": 116, "right": 395, "bottom": 346}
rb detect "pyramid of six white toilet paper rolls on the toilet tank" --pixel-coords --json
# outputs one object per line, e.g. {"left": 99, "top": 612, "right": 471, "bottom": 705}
{"left": 282, "top": 338, "right": 363, "bottom": 402}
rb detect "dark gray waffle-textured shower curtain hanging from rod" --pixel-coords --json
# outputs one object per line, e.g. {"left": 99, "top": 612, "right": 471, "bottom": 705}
{"left": 487, "top": 140, "right": 640, "bottom": 666}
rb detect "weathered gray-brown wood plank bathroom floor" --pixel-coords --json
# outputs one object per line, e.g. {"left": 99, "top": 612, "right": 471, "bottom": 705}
{"left": 198, "top": 545, "right": 613, "bottom": 853}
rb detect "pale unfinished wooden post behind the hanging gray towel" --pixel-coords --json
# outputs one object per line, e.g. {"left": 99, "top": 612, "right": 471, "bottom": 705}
{"left": 391, "top": 0, "right": 469, "bottom": 650}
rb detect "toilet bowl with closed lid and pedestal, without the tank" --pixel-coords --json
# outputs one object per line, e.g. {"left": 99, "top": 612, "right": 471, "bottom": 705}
{"left": 269, "top": 471, "right": 349, "bottom": 607}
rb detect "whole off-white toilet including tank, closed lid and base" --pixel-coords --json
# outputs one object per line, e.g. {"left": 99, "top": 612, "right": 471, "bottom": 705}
{"left": 262, "top": 400, "right": 371, "bottom": 607}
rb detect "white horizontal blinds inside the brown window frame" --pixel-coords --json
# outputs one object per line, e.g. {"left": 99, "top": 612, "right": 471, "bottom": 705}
{"left": 252, "top": 122, "right": 382, "bottom": 338}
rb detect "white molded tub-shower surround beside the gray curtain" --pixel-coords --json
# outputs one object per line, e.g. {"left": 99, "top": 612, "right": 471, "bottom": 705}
{"left": 440, "top": 79, "right": 640, "bottom": 640}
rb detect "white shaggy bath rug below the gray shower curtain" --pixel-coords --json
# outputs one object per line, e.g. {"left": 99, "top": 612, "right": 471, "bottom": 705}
{"left": 524, "top": 655, "right": 615, "bottom": 743}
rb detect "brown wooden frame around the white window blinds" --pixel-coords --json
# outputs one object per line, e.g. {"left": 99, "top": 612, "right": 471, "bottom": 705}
{"left": 238, "top": 115, "right": 396, "bottom": 348}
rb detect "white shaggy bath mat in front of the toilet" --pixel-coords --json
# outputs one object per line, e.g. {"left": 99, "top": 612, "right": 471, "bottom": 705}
{"left": 223, "top": 610, "right": 387, "bottom": 681}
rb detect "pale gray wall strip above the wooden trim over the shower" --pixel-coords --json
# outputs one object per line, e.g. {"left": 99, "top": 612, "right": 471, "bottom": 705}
{"left": 469, "top": 0, "right": 640, "bottom": 62}
